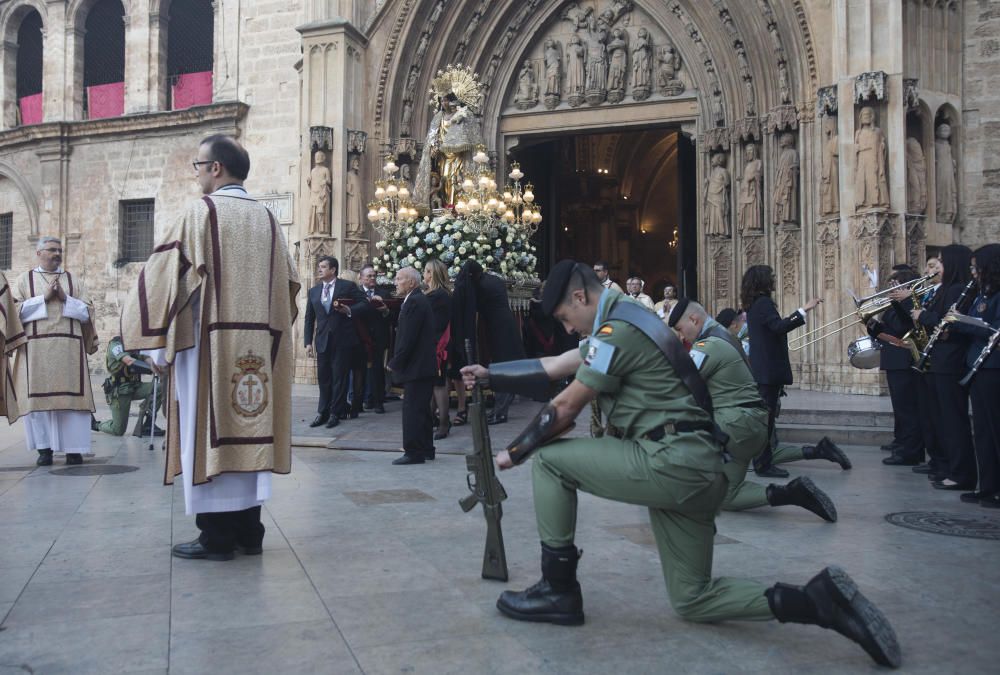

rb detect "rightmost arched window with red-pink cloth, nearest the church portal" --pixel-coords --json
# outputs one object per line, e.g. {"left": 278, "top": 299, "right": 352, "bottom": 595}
{"left": 167, "top": 0, "right": 214, "bottom": 110}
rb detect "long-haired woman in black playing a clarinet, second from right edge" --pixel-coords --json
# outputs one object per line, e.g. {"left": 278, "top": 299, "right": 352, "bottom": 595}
{"left": 910, "top": 244, "right": 976, "bottom": 490}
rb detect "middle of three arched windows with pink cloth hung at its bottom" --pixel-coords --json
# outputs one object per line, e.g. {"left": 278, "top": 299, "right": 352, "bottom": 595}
{"left": 83, "top": 0, "right": 125, "bottom": 120}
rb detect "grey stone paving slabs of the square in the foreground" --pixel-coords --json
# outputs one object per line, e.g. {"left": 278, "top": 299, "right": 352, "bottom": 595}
{"left": 0, "top": 391, "right": 1000, "bottom": 675}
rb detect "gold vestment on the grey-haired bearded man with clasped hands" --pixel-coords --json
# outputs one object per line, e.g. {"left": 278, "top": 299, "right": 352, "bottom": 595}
{"left": 6, "top": 269, "right": 97, "bottom": 422}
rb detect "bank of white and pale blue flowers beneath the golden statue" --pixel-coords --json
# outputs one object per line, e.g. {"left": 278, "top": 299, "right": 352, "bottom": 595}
{"left": 372, "top": 212, "right": 538, "bottom": 282}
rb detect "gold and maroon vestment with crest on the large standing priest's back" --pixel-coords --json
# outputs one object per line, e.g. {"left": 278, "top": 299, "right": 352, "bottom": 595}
{"left": 121, "top": 191, "right": 299, "bottom": 485}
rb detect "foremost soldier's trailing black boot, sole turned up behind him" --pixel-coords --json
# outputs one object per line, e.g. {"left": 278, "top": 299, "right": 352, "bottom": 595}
{"left": 764, "top": 567, "right": 902, "bottom": 668}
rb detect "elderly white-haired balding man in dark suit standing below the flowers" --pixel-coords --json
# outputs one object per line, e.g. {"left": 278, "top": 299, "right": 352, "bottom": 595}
{"left": 389, "top": 267, "right": 438, "bottom": 464}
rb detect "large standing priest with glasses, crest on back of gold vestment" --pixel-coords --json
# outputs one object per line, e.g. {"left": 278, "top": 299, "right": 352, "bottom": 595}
{"left": 121, "top": 135, "right": 299, "bottom": 560}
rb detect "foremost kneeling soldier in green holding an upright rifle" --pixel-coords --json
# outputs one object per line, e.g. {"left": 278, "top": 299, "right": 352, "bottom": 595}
{"left": 462, "top": 260, "right": 900, "bottom": 666}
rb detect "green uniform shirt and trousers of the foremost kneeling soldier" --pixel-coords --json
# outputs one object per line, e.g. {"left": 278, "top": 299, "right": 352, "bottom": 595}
{"left": 532, "top": 290, "right": 774, "bottom": 621}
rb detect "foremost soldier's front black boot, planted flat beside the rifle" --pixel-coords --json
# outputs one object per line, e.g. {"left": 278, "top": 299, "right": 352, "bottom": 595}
{"left": 497, "top": 543, "right": 583, "bottom": 626}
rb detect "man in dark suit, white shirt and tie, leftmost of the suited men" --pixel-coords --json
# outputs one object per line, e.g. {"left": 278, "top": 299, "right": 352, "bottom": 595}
{"left": 303, "top": 256, "right": 368, "bottom": 429}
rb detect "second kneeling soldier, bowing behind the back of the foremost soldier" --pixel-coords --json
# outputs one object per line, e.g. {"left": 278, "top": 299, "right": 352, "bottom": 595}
{"left": 667, "top": 298, "right": 839, "bottom": 523}
